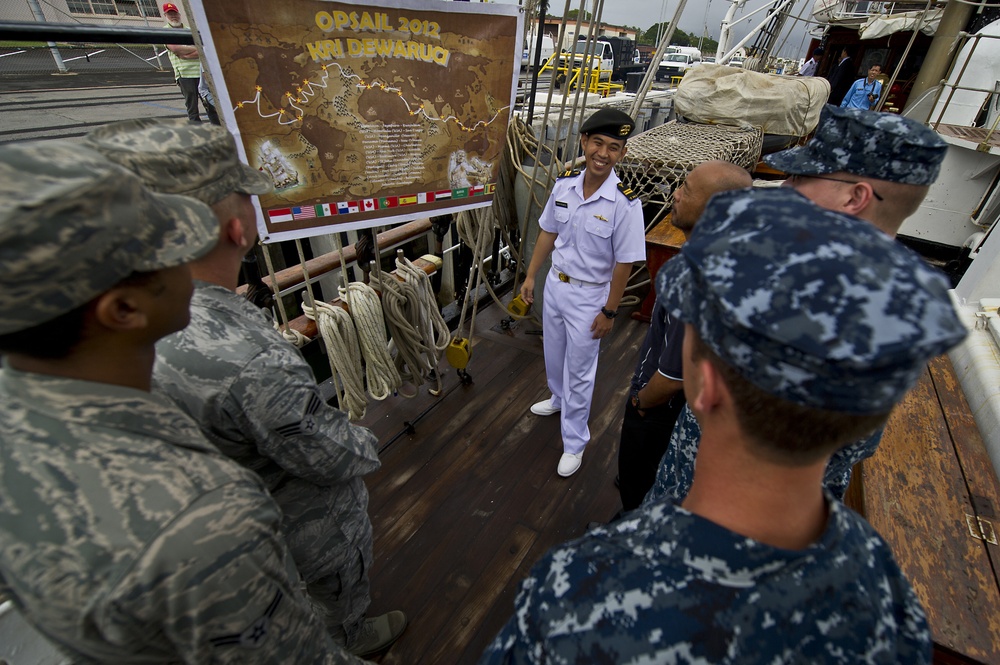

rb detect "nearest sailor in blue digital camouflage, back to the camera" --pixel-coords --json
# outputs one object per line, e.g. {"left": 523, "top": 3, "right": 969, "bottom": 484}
{"left": 481, "top": 189, "right": 965, "bottom": 664}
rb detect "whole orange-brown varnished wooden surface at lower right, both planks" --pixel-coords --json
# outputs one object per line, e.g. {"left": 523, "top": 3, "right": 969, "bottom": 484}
{"left": 847, "top": 356, "right": 1000, "bottom": 665}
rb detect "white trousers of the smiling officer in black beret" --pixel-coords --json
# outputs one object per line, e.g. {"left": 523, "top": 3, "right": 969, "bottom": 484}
{"left": 542, "top": 270, "right": 611, "bottom": 454}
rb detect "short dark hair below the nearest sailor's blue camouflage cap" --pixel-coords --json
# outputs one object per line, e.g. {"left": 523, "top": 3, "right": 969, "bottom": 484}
{"left": 686, "top": 328, "right": 889, "bottom": 466}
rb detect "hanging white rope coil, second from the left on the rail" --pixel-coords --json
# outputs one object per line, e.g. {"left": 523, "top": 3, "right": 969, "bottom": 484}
{"left": 340, "top": 282, "right": 402, "bottom": 401}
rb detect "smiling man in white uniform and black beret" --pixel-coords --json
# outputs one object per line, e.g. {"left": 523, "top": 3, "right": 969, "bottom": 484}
{"left": 521, "top": 109, "right": 646, "bottom": 476}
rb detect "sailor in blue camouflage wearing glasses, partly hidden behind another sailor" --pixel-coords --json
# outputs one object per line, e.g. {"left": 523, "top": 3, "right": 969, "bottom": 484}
{"left": 647, "top": 105, "right": 947, "bottom": 501}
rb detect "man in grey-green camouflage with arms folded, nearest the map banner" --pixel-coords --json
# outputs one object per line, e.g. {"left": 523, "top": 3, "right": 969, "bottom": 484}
{"left": 87, "top": 119, "right": 406, "bottom": 656}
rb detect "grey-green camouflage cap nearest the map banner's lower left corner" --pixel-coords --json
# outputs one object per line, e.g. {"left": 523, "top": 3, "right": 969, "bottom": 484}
{"left": 85, "top": 118, "right": 274, "bottom": 205}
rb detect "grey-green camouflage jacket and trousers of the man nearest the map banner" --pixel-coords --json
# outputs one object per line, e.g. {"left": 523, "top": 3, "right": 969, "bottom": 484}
{"left": 154, "top": 282, "right": 379, "bottom": 643}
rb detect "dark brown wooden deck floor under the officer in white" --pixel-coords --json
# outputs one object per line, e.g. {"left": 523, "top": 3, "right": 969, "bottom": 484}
{"left": 362, "top": 307, "right": 648, "bottom": 665}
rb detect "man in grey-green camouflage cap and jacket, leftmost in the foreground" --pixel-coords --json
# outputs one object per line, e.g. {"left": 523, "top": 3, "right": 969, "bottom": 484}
{"left": 0, "top": 141, "right": 361, "bottom": 665}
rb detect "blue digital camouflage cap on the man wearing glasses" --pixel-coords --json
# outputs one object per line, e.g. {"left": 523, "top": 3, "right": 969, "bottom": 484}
{"left": 764, "top": 104, "right": 948, "bottom": 185}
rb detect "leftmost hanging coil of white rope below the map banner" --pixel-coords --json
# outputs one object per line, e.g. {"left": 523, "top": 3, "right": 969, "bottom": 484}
{"left": 302, "top": 301, "right": 368, "bottom": 420}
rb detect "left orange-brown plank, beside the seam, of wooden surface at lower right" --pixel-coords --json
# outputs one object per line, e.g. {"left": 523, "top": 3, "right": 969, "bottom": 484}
{"left": 862, "top": 359, "right": 1000, "bottom": 663}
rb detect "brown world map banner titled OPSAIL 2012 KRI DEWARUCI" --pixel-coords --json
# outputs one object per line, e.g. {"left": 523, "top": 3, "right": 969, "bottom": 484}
{"left": 190, "top": 0, "right": 523, "bottom": 242}
